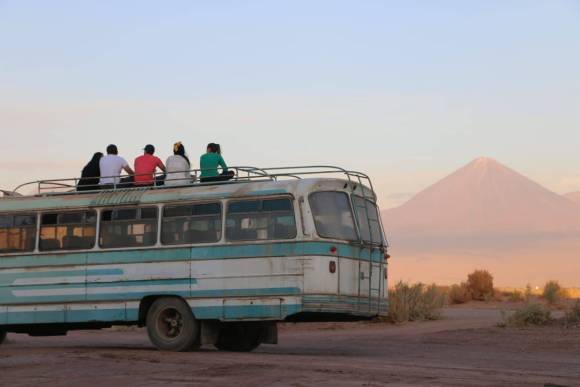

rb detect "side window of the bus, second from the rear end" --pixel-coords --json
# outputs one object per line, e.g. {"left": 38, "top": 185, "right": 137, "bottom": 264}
{"left": 161, "top": 203, "right": 222, "bottom": 245}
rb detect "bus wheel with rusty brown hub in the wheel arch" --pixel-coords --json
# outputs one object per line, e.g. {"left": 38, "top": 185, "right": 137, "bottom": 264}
{"left": 147, "top": 297, "right": 200, "bottom": 352}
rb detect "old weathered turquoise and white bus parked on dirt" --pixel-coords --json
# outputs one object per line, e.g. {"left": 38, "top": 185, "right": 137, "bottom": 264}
{"left": 0, "top": 167, "right": 388, "bottom": 351}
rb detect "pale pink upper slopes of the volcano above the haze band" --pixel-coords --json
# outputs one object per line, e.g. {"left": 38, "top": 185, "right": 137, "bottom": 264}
{"left": 383, "top": 157, "right": 580, "bottom": 236}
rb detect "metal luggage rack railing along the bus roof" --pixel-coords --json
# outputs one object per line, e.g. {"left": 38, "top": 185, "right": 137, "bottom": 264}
{"left": 6, "top": 165, "right": 374, "bottom": 197}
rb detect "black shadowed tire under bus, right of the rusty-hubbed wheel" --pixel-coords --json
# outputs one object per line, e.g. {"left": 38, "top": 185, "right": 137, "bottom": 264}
{"left": 215, "top": 322, "right": 263, "bottom": 352}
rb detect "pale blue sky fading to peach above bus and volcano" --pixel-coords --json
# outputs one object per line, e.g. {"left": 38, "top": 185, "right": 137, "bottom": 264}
{"left": 0, "top": 0, "right": 580, "bottom": 208}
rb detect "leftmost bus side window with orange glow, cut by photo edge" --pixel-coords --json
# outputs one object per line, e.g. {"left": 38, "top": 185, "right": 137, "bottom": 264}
{"left": 0, "top": 214, "right": 36, "bottom": 253}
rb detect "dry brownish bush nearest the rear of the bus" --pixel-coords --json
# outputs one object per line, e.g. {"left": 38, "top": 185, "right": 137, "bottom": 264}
{"left": 389, "top": 281, "right": 445, "bottom": 323}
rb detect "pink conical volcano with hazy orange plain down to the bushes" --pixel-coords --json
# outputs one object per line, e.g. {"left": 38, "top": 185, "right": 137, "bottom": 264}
{"left": 382, "top": 157, "right": 580, "bottom": 286}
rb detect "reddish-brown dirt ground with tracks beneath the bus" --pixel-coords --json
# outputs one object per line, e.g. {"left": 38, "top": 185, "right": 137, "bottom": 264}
{"left": 0, "top": 308, "right": 580, "bottom": 386}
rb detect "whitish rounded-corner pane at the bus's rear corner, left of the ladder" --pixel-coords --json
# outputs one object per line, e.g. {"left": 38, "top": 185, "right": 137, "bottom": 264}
{"left": 309, "top": 192, "right": 358, "bottom": 241}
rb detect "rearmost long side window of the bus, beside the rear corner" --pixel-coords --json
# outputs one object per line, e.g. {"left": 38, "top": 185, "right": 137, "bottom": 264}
{"left": 226, "top": 198, "right": 296, "bottom": 241}
